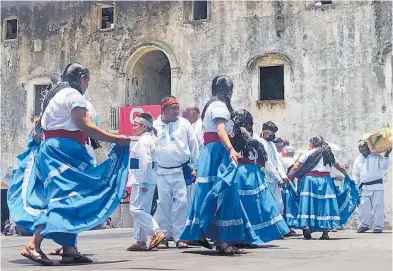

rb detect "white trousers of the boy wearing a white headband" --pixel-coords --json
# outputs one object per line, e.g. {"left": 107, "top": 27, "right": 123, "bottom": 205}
{"left": 130, "top": 184, "right": 159, "bottom": 242}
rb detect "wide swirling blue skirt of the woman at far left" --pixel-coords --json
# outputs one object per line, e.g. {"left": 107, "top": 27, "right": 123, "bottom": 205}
{"left": 8, "top": 138, "right": 129, "bottom": 242}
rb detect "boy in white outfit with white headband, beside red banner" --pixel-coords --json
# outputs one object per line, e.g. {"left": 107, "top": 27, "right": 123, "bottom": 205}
{"left": 127, "top": 113, "right": 165, "bottom": 251}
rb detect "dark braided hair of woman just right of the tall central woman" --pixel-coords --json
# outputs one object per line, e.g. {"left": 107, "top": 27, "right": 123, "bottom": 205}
{"left": 231, "top": 109, "right": 267, "bottom": 167}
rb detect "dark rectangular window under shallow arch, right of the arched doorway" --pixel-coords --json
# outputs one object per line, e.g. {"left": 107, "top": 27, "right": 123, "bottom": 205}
{"left": 259, "top": 66, "right": 284, "bottom": 100}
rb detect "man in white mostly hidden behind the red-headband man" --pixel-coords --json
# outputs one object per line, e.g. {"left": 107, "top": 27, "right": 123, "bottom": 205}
{"left": 182, "top": 104, "right": 203, "bottom": 204}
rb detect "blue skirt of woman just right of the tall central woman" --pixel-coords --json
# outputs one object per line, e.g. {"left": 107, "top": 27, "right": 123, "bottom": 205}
{"left": 235, "top": 164, "right": 289, "bottom": 245}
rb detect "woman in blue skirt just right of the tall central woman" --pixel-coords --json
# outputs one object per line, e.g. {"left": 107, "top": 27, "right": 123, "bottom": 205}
{"left": 231, "top": 109, "right": 289, "bottom": 246}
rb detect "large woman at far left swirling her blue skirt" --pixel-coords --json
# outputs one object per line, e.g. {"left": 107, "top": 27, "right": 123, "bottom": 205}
{"left": 8, "top": 63, "right": 130, "bottom": 265}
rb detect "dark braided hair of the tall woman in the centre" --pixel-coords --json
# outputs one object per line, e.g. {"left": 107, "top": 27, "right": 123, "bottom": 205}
{"left": 202, "top": 76, "right": 233, "bottom": 120}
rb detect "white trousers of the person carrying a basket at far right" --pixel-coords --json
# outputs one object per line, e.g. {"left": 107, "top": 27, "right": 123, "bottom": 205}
{"left": 359, "top": 190, "right": 384, "bottom": 230}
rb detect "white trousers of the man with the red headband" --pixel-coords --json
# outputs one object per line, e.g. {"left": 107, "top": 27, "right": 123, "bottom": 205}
{"left": 154, "top": 172, "right": 190, "bottom": 242}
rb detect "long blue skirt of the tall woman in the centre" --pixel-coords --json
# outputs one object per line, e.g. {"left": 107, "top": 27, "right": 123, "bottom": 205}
{"left": 180, "top": 142, "right": 240, "bottom": 242}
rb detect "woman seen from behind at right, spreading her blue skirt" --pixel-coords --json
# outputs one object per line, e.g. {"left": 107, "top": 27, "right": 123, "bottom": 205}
{"left": 288, "top": 136, "right": 358, "bottom": 240}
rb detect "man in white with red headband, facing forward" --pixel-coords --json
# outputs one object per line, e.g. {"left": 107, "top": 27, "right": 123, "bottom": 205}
{"left": 154, "top": 96, "right": 199, "bottom": 248}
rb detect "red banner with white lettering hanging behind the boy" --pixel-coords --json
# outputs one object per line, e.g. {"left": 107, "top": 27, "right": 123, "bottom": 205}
{"left": 119, "top": 105, "right": 161, "bottom": 136}
